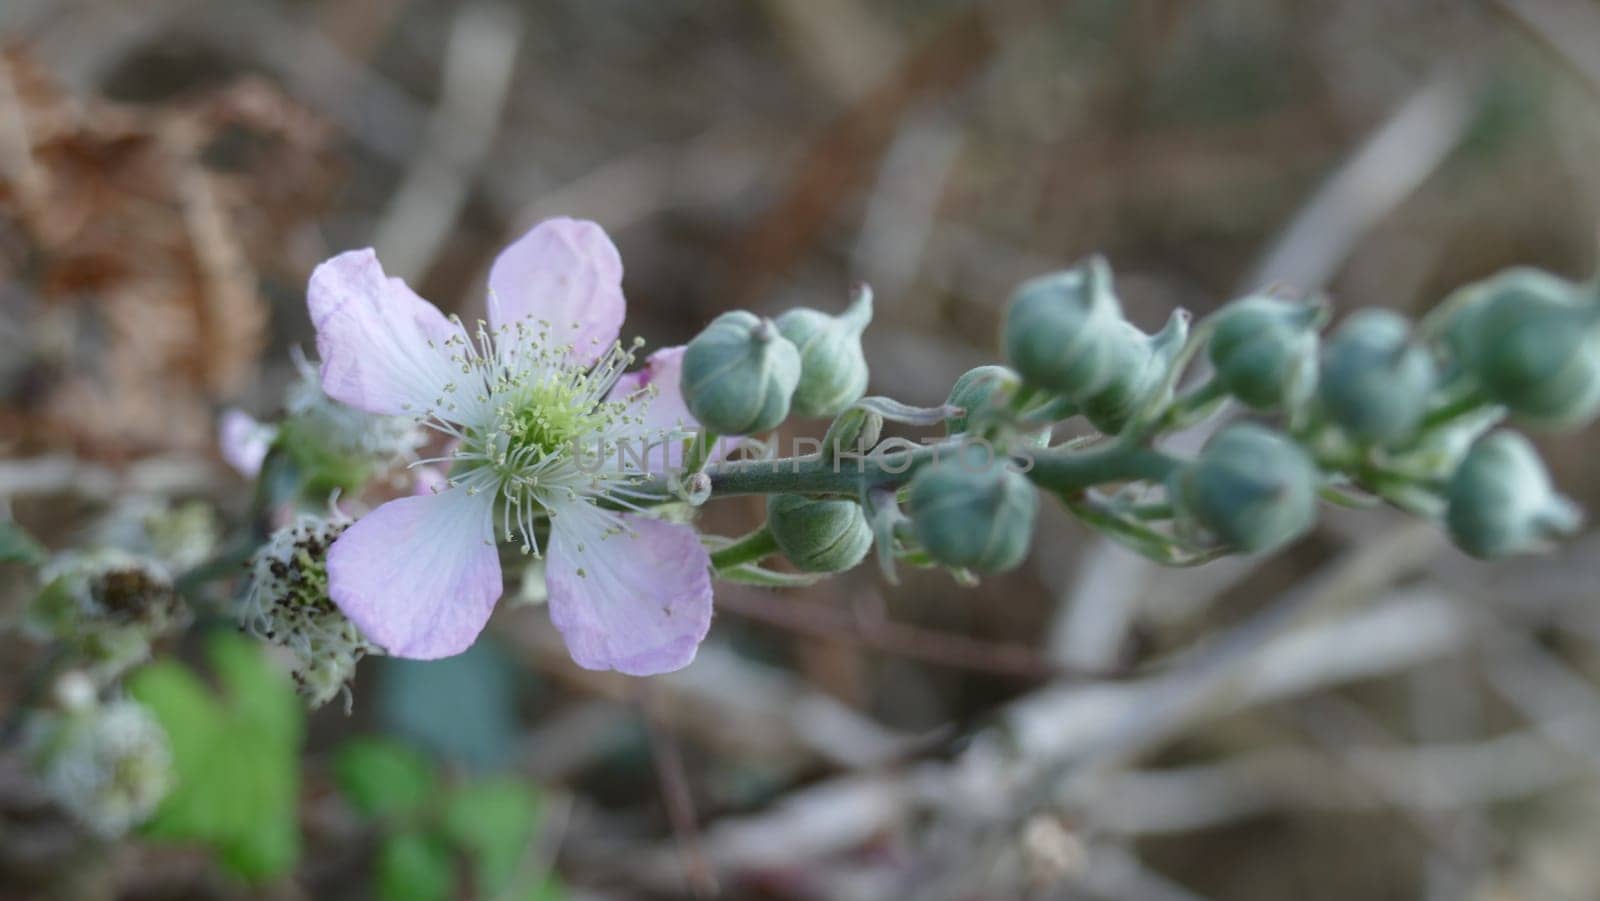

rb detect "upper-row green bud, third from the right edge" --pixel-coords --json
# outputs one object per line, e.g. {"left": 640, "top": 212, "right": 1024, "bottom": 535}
{"left": 1206, "top": 294, "right": 1328, "bottom": 410}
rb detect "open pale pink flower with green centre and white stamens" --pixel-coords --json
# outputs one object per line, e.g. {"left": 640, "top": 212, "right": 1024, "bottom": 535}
{"left": 309, "top": 219, "right": 712, "bottom": 675}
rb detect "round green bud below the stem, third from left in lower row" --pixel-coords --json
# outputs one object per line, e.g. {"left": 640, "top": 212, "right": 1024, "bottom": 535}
{"left": 1166, "top": 422, "right": 1320, "bottom": 554}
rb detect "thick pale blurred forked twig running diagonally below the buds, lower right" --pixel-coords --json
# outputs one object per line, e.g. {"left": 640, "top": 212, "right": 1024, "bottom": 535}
{"left": 627, "top": 525, "right": 1474, "bottom": 871}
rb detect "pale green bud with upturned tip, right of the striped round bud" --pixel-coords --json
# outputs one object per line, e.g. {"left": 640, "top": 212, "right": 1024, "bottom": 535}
{"left": 778, "top": 285, "right": 872, "bottom": 416}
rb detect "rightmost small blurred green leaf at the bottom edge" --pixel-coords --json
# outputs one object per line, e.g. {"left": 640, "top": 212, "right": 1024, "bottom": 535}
{"left": 443, "top": 776, "right": 539, "bottom": 895}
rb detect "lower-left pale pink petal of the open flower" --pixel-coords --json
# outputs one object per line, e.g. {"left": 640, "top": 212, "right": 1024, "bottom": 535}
{"left": 328, "top": 488, "right": 501, "bottom": 659}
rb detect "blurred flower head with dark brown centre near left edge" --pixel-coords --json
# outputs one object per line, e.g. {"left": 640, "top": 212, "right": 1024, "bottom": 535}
{"left": 22, "top": 549, "right": 189, "bottom": 683}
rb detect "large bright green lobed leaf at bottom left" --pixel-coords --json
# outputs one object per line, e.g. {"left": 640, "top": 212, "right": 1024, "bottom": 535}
{"left": 128, "top": 632, "right": 304, "bottom": 880}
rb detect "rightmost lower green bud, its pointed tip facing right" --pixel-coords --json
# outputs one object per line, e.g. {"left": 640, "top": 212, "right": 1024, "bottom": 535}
{"left": 1445, "top": 432, "right": 1582, "bottom": 557}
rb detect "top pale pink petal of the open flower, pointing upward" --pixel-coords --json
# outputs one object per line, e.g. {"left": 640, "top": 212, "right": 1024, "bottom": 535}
{"left": 490, "top": 219, "right": 627, "bottom": 363}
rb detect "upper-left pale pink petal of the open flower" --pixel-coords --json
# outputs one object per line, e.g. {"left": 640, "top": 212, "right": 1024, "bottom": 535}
{"left": 306, "top": 248, "right": 461, "bottom": 416}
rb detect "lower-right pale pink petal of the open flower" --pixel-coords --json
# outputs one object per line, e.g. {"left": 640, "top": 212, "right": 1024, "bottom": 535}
{"left": 544, "top": 514, "right": 710, "bottom": 675}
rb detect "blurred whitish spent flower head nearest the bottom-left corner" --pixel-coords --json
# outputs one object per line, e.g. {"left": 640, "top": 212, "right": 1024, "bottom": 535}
{"left": 26, "top": 672, "right": 173, "bottom": 839}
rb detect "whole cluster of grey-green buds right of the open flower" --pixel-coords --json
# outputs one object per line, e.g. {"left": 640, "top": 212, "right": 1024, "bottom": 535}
{"left": 665, "top": 258, "right": 1600, "bottom": 585}
